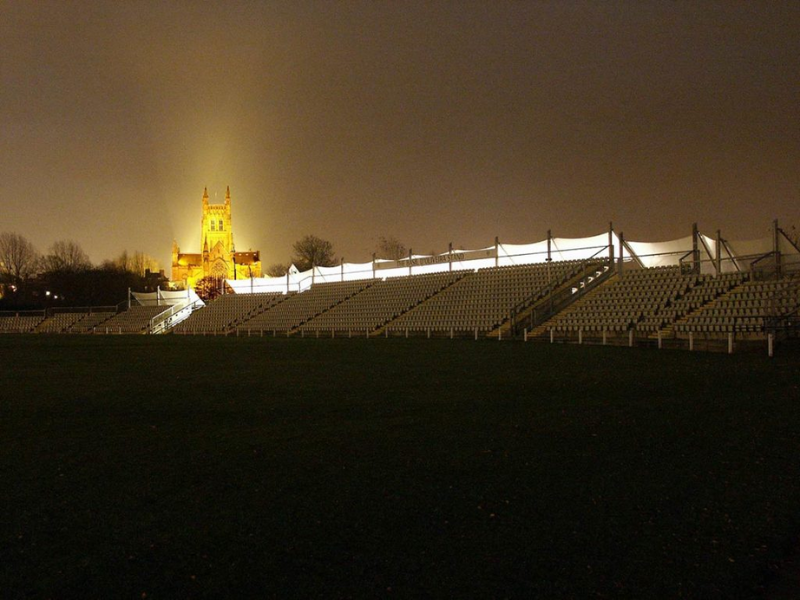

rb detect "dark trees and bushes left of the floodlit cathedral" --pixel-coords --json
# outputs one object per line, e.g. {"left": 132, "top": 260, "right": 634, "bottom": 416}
{"left": 0, "top": 232, "right": 164, "bottom": 310}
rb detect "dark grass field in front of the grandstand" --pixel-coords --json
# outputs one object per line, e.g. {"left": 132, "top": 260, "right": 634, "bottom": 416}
{"left": 0, "top": 336, "right": 800, "bottom": 598}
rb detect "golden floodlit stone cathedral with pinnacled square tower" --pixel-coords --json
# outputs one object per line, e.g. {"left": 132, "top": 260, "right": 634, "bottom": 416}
{"left": 172, "top": 186, "right": 261, "bottom": 287}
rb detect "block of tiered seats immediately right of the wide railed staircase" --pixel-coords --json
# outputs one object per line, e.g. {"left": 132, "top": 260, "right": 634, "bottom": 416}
{"left": 550, "top": 267, "right": 698, "bottom": 332}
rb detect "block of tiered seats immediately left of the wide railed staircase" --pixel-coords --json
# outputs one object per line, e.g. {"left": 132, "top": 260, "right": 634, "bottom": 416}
{"left": 388, "top": 261, "right": 582, "bottom": 332}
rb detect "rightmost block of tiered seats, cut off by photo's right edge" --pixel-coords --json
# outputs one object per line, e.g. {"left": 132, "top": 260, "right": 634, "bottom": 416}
{"left": 675, "top": 275, "right": 800, "bottom": 334}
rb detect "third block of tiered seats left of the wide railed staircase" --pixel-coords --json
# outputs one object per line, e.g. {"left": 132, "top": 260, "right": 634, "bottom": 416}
{"left": 236, "top": 279, "right": 375, "bottom": 332}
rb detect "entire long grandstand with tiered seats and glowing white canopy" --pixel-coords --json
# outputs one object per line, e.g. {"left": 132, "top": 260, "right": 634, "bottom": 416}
{"left": 0, "top": 223, "right": 800, "bottom": 348}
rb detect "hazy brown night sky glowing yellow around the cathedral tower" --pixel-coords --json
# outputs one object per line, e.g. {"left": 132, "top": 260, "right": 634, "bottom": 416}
{"left": 0, "top": 0, "right": 800, "bottom": 271}
